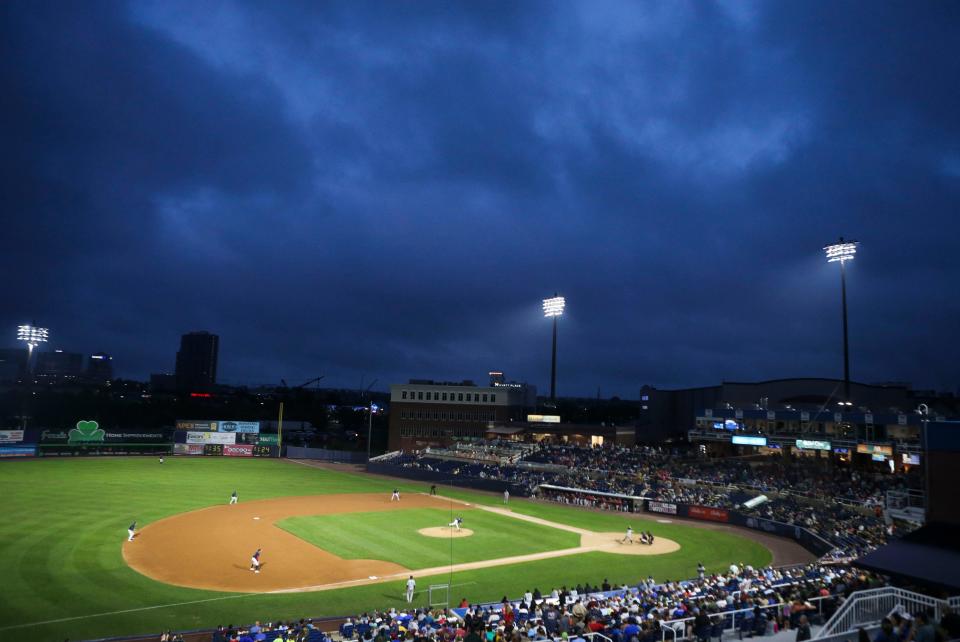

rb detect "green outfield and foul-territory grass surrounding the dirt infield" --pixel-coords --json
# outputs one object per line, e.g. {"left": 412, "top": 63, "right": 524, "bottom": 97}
{"left": 0, "top": 457, "right": 771, "bottom": 640}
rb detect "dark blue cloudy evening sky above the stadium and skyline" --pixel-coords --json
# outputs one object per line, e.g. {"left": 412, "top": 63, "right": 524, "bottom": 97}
{"left": 0, "top": 0, "right": 960, "bottom": 396}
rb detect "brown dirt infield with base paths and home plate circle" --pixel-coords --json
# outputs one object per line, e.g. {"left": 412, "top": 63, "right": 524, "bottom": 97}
{"left": 123, "top": 494, "right": 680, "bottom": 593}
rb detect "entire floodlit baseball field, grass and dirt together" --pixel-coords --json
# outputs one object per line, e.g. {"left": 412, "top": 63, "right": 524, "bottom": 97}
{"left": 0, "top": 457, "right": 771, "bottom": 640}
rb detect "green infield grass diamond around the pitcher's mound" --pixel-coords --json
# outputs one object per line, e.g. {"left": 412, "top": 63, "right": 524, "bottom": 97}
{"left": 277, "top": 507, "right": 580, "bottom": 569}
